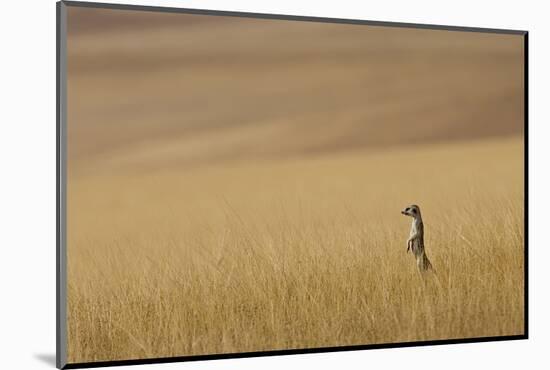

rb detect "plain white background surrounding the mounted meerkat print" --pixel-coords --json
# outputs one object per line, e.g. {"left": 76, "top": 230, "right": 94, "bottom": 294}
{"left": 0, "top": 0, "right": 550, "bottom": 370}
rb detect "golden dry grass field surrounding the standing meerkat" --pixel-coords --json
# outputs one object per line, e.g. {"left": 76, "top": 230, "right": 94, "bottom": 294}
{"left": 68, "top": 138, "right": 524, "bottom": 362}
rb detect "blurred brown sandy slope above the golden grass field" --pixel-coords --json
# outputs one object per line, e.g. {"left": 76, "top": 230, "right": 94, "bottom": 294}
{"left": 68, "top": 8, "right": 524, "bottom": 172}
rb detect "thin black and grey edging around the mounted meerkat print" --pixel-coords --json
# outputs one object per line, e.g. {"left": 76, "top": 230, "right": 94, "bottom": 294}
{"left": 56, "top": 0, "right": 529, "bottom": 369}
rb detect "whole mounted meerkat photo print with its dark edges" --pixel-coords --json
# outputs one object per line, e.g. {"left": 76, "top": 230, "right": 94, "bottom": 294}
{"left": 57, "top": 1, "right": 527, "bottom": 368}
